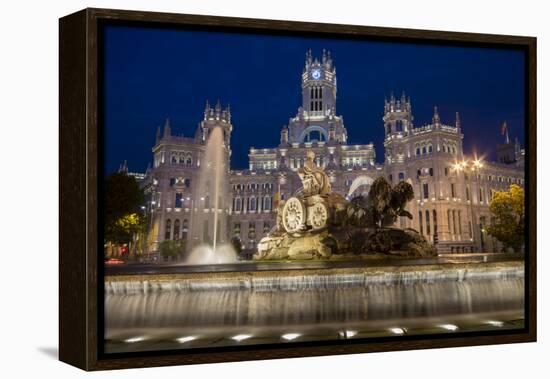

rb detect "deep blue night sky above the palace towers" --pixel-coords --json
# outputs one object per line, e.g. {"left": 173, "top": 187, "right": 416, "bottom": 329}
{"left": 104, "top": 26, "right": 525, "bottom": 173}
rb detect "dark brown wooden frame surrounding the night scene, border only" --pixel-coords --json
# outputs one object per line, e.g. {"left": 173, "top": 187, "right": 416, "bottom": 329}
{"left": 59, "top": 9, "right": 537, "bottom": 370}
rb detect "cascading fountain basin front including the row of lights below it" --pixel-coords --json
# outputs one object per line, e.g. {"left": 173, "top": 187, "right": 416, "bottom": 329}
{"left": 105, "top": 262, "right": 525, "bottom": 352}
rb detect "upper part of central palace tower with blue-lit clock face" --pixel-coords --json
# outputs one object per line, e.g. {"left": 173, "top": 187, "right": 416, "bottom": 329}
{"left": 302, "top": 49, "right": 336, "bottom": 116}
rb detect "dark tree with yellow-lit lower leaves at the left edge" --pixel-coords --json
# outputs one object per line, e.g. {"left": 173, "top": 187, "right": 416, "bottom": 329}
{"left": 104, "top": 173, "right": 145, "bottom": 244}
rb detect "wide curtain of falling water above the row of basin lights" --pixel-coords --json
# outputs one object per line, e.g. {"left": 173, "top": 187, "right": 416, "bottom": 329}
{"left": 105, "top": 267, "right": 524, "bottom": 334}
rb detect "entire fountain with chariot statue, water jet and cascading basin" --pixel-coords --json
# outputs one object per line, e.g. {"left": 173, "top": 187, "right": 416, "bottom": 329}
{"left": 105, "top": 148, "right": 525, "bottom": 353}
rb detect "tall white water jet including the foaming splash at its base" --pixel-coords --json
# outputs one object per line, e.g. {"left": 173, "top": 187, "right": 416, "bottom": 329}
{"left": 188, "top": 126, "right": 237, "bottom": 265}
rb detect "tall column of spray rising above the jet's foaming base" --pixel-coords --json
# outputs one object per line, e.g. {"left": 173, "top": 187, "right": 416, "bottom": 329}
{"left": 192, "top": 126, "right": 229, "bottom": 260}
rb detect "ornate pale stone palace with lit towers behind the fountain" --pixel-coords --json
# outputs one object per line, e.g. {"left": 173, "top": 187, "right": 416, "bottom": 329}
{"left": 139, "top": 52, "right": 524, "bottom": 252}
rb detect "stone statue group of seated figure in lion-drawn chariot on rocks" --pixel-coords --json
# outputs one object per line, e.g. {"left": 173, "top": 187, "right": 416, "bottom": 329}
{"left": 254, "top": 151, "right": 436, "bottom": 260}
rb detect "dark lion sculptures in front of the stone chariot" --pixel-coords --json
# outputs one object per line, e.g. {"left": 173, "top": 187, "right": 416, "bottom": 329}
{"left": 347, "top": 177, "right": 414, "bottom": 227}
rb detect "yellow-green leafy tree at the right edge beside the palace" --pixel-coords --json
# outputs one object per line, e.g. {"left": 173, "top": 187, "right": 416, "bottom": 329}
{"left": 487, "top": 184, "right": 525, "bottom": 251}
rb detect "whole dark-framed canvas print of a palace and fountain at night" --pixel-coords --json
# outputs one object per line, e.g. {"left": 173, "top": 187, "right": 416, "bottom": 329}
{"left": 59, "top": 9, "right": 536, "bottom": 370}
